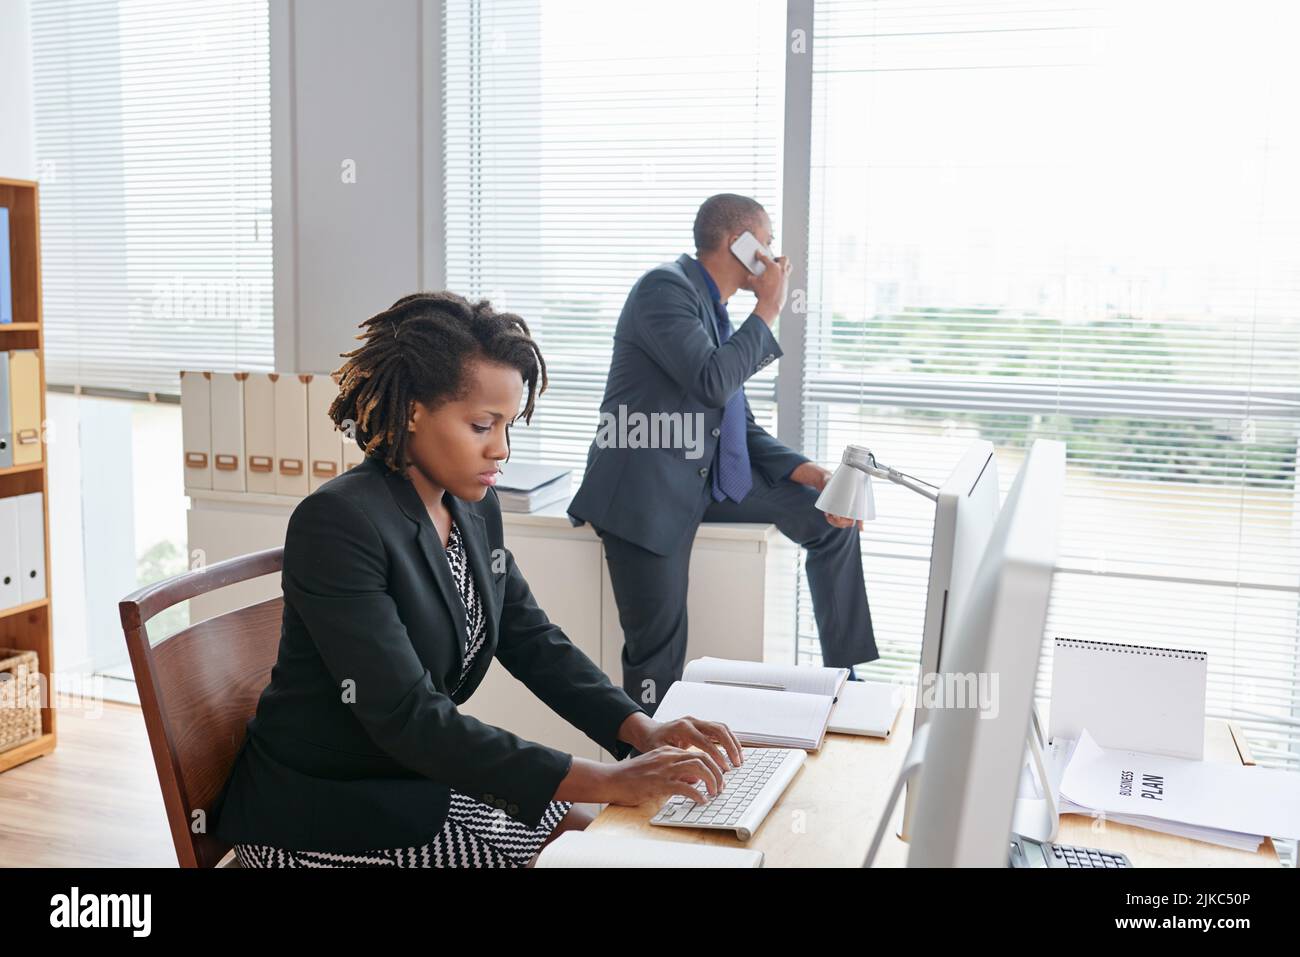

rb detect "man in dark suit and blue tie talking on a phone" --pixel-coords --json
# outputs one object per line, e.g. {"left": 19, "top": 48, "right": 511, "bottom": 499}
{"left": 568, "top": 194, "right": 879, "bottom": 714}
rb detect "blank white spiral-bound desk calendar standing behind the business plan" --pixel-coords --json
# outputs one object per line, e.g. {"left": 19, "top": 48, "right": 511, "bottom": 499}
{"left": 1048, "top": 638, "right": 1206, "bottom": 761}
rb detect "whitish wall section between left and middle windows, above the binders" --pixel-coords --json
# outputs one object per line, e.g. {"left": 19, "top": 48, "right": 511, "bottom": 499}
{"left": 270, "top": 0, "right": 443, "bottom": 372}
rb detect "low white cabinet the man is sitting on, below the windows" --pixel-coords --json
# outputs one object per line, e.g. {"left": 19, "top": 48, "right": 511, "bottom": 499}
{"left": 189, "top": 489, "right": 797, "bottom": 759}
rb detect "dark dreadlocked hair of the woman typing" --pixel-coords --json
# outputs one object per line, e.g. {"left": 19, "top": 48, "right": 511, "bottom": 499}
{"left": 329, "top": 293, "right": 546, "bottom": 471}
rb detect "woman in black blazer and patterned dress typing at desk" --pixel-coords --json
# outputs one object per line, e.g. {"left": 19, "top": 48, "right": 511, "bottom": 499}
{"left": 213, "top": 293, "right": 741, "bottom": 867}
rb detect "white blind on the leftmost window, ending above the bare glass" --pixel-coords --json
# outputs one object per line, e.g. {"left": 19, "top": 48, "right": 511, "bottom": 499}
{"left": 31, "top": 0, "right": 274, "bottom": 394}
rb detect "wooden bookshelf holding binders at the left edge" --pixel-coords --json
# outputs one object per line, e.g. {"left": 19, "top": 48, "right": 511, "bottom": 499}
{"left": 0, "top": 178, "right": 57, "bottom": 771}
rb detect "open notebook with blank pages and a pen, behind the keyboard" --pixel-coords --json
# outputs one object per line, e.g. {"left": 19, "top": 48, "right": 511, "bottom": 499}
{"left": 654, "top": 658, "right": 849, "bottom": 752}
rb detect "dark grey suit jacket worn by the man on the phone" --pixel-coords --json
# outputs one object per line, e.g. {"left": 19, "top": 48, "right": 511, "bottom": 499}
{"left": 568, "top": 255, "right": 809, "bottom": 555}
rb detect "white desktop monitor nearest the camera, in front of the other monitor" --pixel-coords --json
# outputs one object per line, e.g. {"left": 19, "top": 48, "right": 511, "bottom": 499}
{"left": 907, "top": 439, "right": 1065, "bottom": 867}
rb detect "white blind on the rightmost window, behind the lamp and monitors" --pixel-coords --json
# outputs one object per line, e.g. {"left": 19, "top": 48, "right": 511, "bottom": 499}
{"left": 800, "top": 0, "right": 1300, "bottom": 768}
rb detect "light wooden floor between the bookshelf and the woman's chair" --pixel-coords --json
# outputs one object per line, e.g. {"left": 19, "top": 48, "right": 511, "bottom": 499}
{"left": 0, "top": 701, "right": 177, "bottom": 867}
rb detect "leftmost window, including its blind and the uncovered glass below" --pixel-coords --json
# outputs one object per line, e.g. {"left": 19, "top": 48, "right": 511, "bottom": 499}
{"left": 31, "top": 0, "right": 273, "bottom": 698}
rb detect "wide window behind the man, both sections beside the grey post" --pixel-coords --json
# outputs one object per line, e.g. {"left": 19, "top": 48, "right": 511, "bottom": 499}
{"left": 443, "top": 0, "right": 1300, "bottom": 780}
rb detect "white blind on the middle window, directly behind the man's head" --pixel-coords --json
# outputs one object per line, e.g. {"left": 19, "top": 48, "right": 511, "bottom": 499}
{"left": 442, "top": 0, "right": 785, "bottom": 469}
